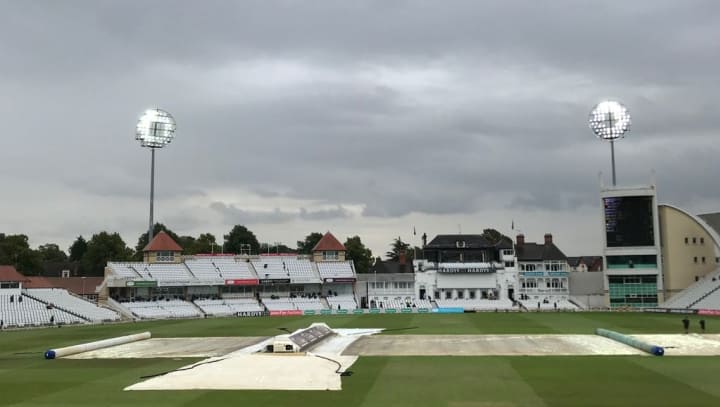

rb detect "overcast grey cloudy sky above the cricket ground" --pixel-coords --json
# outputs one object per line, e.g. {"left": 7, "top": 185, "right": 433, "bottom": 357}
{"left": 0, "top": 0, "right": 720, "bottom": 256}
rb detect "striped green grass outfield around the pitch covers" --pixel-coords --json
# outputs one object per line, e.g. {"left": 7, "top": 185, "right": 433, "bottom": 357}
{"left": 0, "top": 313, "right": 720, "bottom": 407}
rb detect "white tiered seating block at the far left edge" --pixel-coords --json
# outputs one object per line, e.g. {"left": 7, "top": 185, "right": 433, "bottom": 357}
{"left": 0, "top": 294, "right": 86, "bottom": 327}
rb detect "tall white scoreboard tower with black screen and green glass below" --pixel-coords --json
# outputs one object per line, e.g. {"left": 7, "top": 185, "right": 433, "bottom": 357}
{"left": 600, "top": 185, "right": 663, "bottom": 308}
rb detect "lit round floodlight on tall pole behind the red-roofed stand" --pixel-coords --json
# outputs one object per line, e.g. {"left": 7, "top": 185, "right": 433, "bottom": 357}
{"left": 135, "top": 108, "right": 175, "bottom": 243}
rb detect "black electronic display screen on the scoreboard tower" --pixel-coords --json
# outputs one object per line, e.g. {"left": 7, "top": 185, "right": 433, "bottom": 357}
{"left": 603, "top": 196, "right": 655, "bottom": 247}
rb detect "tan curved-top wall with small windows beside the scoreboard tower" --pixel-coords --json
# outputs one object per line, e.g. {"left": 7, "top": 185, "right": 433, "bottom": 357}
{"left": 659, "top": 205, "right": 718, "bottom": 300}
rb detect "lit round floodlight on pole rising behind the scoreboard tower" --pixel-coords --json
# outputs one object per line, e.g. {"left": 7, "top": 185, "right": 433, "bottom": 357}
{"left": 588, "top": 100, "right": 630, "bottom": 186}
